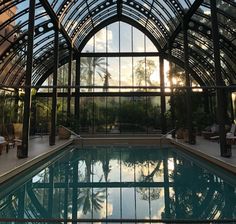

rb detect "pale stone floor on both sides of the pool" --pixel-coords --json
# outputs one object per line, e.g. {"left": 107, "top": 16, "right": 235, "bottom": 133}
{"left": 0, "top": 136, "right": 236, "bottom": 183}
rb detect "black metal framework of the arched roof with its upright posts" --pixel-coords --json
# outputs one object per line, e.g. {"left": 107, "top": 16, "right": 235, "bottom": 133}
{"left": 0, "top": 0, "right": 236, "bottom": 156}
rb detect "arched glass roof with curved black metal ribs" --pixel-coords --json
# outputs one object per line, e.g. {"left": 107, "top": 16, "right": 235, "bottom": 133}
{"left": 0, "top": 0, "right": 236, "bottom": 86}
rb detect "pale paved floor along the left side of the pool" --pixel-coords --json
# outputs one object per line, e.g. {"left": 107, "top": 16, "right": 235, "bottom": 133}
{"left": 0, "top": 136, "right": 72, "bottom": 183}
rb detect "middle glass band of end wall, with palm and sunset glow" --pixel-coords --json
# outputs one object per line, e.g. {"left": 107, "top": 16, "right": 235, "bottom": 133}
{"left": 80, "top": 57, "right": 162, "bottom": 92}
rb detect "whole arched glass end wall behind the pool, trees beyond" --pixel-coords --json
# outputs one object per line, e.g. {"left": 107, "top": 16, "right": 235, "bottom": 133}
{"left": 36, "top": 22, "right": 210, "bottom": 134}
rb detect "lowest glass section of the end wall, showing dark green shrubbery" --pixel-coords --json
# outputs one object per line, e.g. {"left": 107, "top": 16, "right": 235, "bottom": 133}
{"left": 80, "top": 96, "right": 161, "bottom": 134}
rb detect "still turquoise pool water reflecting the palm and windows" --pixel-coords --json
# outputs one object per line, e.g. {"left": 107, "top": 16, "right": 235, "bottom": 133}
{"left": 0, "top": 146, "right": 236, "bottom": 223}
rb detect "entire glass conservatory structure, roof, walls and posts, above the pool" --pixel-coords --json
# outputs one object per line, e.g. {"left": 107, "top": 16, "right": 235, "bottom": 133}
{"left": 0, "top": 0, "right": 236, "bottom": 158}
